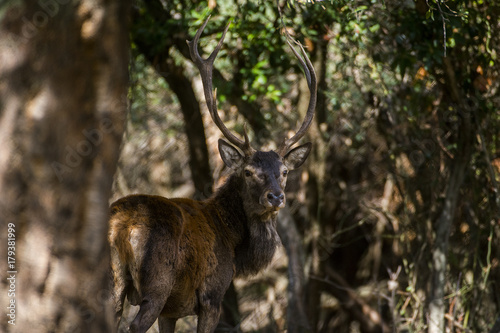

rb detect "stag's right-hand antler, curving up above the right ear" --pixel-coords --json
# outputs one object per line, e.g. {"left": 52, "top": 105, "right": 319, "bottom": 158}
{"left": 278, "top": 35, "right": 318, "bottom": 155}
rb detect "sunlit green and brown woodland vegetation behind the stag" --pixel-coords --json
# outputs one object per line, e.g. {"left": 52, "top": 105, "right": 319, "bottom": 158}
{"left": 114, "top": 0, "right": 500, "bottom": 332}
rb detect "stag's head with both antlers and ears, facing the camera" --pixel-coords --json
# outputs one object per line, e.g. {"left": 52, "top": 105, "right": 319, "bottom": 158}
{"left": 187, "top": 17, "right": 317, "bottom": 215}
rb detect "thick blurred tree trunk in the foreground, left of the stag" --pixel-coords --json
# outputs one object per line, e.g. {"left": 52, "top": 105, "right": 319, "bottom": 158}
{"left": 0, "top": 0, "right": 129, "bottom": 332}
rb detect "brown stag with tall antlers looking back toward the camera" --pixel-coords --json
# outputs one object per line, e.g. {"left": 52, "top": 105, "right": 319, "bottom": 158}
{"left": 108, "top": 16, "right": 317, "bottom": 333}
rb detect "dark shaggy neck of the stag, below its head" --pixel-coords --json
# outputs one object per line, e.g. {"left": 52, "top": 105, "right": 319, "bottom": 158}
{"left": 214, "top": 175, "right": 280, "bottom": 276}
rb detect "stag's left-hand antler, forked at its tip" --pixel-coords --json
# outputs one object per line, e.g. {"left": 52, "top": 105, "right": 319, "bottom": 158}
{"left": 186, "top": 16, "right": 254, "bottom": 155}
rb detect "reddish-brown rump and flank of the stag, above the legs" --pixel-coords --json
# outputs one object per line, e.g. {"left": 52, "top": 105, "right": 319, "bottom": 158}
{"left": 109, "top": 195, "right": 227, "bottom": 304}
